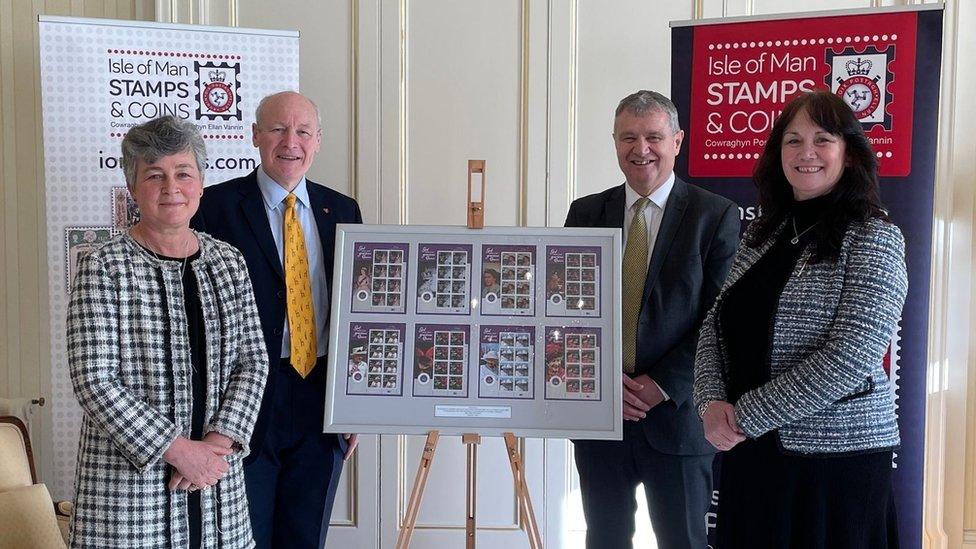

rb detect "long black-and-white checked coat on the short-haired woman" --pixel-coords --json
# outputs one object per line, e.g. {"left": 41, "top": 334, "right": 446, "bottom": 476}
{"left": 67, "top": 233, "right": 268, "bottom": 548}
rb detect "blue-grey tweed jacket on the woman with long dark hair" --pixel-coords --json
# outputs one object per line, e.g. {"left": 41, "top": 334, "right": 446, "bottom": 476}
{"left": 694, "top": 219, "right": 908, "bottom": 455}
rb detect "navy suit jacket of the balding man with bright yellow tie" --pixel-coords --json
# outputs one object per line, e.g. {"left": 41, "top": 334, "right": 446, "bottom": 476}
{"left": 190, "top": 170, "right": 363, "bottom": 463}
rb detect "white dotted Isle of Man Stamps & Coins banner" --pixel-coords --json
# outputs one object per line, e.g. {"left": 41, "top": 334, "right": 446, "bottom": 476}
{"left": 40, "top": 17, "right": 298, "bottom": 498}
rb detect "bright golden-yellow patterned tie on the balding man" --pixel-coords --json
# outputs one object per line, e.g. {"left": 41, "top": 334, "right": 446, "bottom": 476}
{"left": 285, "top": 193, "right": 318, "bottom": 378}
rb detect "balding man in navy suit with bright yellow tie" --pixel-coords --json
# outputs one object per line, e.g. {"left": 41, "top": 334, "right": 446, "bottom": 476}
{"left": 192, "top": 92, "right": 362, "bottom": 549}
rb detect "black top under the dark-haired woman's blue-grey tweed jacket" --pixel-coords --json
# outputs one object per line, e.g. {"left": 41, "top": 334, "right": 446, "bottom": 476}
{"left": 719, "top": 195, "right": 831, "bottom": 404}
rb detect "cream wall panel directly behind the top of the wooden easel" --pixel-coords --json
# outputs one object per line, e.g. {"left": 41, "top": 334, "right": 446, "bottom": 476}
{"left": 406, "top": 0, "right": 522, "bottom": 226}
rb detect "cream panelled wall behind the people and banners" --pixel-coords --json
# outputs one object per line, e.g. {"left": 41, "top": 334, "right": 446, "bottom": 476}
{"left": 0, "top": 0, "right": 976, "bottom": 547}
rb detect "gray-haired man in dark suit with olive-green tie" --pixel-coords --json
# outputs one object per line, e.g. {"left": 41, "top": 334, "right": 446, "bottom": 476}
{"left": 566, "top": 90, "right": 739, "bottom": 549}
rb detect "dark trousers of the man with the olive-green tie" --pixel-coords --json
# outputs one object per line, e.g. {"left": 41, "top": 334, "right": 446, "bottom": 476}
{"left": 574, "top": 421, "right": 714, "bottom": 549}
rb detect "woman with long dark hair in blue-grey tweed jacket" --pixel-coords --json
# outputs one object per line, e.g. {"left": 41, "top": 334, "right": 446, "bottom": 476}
{"left": 694, "top": 91, "right": 908, "bottom": 549}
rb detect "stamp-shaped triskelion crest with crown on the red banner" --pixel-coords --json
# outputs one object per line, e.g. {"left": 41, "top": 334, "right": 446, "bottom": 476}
{"left": 826, "top": 45, "right": 895, "bottom": 130}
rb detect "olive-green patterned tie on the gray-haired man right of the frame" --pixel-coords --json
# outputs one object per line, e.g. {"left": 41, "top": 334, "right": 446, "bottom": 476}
{"left": 621, "top": 197, "right": 651, "bottom": 374}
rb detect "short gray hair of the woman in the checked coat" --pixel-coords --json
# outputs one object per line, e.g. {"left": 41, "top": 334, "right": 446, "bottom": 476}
{"left": 122, "top": 115, "right": 207, "bottom": 191}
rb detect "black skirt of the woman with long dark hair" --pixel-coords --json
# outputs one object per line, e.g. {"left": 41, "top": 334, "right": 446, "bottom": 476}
{"left": 715, "top": 433, "right": 898, "bottom": 549}
